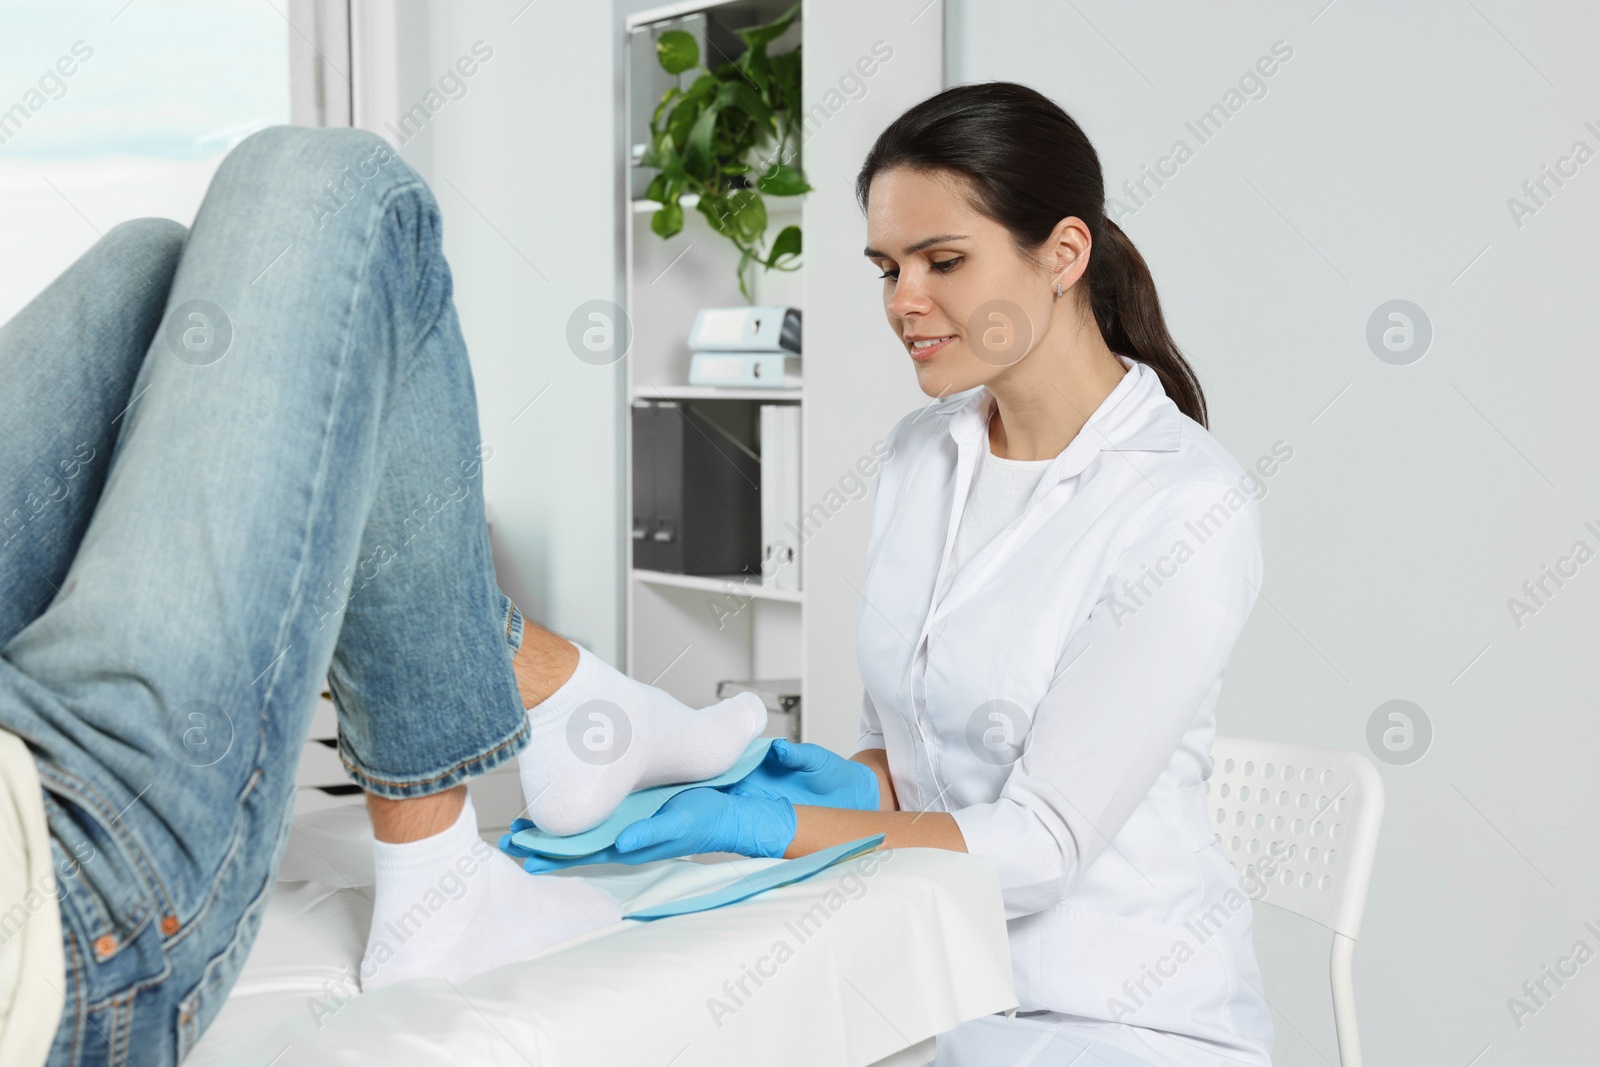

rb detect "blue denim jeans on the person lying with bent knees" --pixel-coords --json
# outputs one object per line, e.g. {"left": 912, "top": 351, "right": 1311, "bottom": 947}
{"left": 0, "top": 126, "right": 528, "bottom": 1067}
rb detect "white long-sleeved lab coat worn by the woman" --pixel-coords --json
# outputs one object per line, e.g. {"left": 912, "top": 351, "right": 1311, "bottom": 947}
{"left": 856, "top": 360, "right": 1272, "bottom": 1065}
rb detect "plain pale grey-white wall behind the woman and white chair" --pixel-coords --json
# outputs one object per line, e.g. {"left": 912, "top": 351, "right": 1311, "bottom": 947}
{"left": 947, "top": 0, "right": 1600, "bottom": 1067}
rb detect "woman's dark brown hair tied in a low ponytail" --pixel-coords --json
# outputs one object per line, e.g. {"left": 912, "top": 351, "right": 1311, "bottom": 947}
{"left": 856, "top": 82, "right": 1206, "bottom": 426}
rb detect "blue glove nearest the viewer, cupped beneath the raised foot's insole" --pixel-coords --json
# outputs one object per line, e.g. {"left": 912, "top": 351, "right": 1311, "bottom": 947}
{"left": 501, "top": 787, "right": 795, "bottom": 875}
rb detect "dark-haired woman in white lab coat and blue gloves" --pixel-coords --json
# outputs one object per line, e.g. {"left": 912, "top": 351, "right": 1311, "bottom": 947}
{"left": 518, "top": 83, "right": 1272, "bottom": 1067}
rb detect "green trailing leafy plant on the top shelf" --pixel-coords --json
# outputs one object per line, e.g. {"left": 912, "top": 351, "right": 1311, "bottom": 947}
{"left": 640, "top": 3, "right": 811, "bottom": 299}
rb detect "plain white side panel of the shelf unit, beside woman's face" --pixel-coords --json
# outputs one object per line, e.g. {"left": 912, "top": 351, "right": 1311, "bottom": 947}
{"left": 800, "top": 0, "right": 942, "bottom": 753}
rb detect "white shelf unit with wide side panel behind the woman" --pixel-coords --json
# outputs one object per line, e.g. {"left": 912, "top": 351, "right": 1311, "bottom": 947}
{"left": 618, "top": 0, "right": 942, "bottom": 755}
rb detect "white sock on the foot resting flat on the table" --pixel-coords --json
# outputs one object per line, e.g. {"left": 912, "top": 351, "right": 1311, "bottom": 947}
{"left": 360, "top": 797, "right": 622, "bottom": 990}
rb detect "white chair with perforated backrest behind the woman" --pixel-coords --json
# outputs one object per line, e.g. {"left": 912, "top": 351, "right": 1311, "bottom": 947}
{"left": 1206, "top": 737, "right": 1384, "bottom": 1067}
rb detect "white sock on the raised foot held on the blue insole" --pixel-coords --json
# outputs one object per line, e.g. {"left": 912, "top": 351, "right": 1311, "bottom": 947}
{"left": 517, "top": 646, "right": 766, "bottom": 833}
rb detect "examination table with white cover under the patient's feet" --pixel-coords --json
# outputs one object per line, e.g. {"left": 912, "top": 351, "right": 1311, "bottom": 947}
{"left": 184, "top": 801, "right": 1016, "bottom": 1067}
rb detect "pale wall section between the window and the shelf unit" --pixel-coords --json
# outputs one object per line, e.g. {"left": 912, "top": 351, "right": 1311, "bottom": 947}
{"left": 371, "top": 0, "right": 622, "bottom": 662}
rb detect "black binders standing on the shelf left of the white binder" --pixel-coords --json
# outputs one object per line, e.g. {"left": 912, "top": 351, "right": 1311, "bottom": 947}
{"left": 632, "top": 400, "right": 762, "bottom": 574}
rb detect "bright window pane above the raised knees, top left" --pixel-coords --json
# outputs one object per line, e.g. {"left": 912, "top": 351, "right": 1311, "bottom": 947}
{"left": 0, "top": 0, "right": 294, "bottom": 322}
